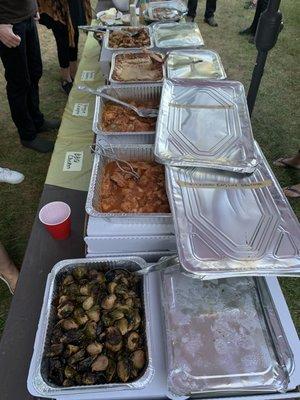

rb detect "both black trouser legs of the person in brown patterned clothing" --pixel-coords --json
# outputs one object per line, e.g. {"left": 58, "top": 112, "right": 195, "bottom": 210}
{"left": 51, "top": 21, "right": 79, "bottom": 68}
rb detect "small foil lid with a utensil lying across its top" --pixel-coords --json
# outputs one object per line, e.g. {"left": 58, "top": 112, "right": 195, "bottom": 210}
{"left": 166, "top": 49, "right": 226, "bottom": 79}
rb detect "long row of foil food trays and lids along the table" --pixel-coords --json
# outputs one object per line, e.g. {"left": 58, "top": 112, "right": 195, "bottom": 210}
{"left": 28, "top": 10, "right": 300, "bottom": 400}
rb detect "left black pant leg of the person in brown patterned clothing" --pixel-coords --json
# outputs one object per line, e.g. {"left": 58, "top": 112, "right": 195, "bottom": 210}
{"left": 51, "top": 20, "right": 70, "bottom": 68}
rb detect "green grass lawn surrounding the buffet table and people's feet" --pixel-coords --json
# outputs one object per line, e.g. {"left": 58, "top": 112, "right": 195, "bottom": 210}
{"left": 0, "top": 0, "right": 300, "bottom": 334}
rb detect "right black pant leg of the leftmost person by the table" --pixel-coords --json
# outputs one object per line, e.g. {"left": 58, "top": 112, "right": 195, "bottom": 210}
{"left": 26, "top": 18, "right": 44, "bottom": 128}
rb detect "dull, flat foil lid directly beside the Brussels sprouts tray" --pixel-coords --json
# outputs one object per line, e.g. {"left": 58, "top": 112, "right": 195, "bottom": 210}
{"left": 161, "top": 267, "right": 294, "bottom": 398}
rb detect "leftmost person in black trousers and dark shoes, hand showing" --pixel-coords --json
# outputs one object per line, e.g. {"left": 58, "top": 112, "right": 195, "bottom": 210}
{"left": 0, "top": 0, "right": 59, "bottom": 153}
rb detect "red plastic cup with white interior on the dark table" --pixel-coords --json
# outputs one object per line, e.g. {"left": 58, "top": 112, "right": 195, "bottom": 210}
{"left": 39, "top": 201, "right": 71, "bottom": 240}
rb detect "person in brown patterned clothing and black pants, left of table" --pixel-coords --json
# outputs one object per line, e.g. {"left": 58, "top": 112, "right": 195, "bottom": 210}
{"left": 38, "top": 0, "right": 92, "bottom": 94}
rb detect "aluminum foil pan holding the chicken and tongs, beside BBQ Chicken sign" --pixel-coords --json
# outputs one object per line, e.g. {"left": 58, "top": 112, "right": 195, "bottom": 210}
{"left": 85, "top": 145, "right": 172, "bottom": 224}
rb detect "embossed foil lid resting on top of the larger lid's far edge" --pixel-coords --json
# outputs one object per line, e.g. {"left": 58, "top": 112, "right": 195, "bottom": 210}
{"left": 154, "top": 80, "right": 257, "bottom": 173}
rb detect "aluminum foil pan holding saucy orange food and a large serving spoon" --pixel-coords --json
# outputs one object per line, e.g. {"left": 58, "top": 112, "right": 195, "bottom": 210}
{"left": 93, "top": 84, "right": 162, "bottom": 144}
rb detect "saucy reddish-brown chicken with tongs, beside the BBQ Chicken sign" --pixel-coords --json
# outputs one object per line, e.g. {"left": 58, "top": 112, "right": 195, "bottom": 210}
{"left": 99, "top": 161, "right": 170, "bottom": 213}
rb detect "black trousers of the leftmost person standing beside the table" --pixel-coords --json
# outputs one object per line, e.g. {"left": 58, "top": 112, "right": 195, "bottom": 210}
{"left": 0, "top": 18, "right": 44, "bottom": 140}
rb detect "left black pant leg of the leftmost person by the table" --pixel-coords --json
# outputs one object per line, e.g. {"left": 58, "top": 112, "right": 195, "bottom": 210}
{"left": 0, "top": 21, "right": 36, "bottom": 140}
